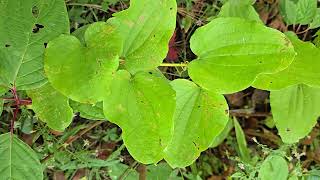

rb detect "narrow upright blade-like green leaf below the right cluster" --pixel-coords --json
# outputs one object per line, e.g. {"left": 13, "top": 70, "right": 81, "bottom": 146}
{"left": 233, "top": 119, "right": 251, "bottom": 163}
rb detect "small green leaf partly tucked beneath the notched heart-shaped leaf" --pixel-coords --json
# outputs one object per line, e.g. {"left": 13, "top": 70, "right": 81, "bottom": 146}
{"left": 27, "top": 83, "right": 73, "bottom": 131}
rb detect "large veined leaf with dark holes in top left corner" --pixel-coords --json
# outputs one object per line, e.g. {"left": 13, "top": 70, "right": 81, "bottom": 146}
{"left": 0, "top": 0, "right": 69, "bottom": 90}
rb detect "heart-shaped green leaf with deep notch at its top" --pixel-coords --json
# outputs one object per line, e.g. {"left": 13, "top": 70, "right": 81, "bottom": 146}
{"left": 45, "top": 22, "right": 122, "bottom": 104}
